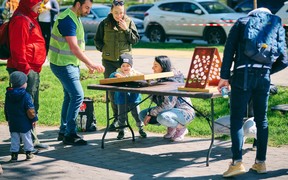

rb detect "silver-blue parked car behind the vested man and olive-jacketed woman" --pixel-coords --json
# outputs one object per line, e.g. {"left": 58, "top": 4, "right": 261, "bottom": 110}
{"left": 60, "top": 4, "right": 144, "bottom": 42}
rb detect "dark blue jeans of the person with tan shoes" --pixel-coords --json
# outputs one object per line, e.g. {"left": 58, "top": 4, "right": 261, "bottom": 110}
{"left": 230, "top": 68, "right": 270, "bottom": 161}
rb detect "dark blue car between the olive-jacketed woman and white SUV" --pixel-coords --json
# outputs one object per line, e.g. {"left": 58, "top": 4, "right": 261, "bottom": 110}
{"left": 126, "top": 4, "right": 153, "bottom": 20}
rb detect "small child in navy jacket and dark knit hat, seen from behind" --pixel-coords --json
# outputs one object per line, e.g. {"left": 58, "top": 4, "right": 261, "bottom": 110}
{"left": 4, "top": 71, "right": 38, "bottom": 162}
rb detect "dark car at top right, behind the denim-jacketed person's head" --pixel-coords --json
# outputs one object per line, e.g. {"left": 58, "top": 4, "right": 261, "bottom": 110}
{"left": 234, "top": 0, "right": 287, "bottom": 14}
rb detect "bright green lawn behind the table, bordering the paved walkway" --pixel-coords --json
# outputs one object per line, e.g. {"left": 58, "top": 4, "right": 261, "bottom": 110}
{"left": 0, "top": 64, "right": 288, "bottom": 146}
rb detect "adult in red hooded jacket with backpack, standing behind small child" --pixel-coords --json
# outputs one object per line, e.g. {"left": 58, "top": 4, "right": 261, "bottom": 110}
{"left": 7, "top": 0, "right": 48, "bottom": 149}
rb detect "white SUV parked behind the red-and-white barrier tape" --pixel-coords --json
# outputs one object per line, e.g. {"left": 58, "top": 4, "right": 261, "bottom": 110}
{"left": 144, "top": 0, "right": 245, "bottom": 44}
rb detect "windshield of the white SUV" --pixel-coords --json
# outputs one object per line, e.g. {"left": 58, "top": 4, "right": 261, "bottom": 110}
{"left": 199, "top": 2, "right": 234, "bottom": 14}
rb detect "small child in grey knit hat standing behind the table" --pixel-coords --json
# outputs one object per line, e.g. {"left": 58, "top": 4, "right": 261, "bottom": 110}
{"left": 110, "top": 53, "right": 147, "bottom": 140}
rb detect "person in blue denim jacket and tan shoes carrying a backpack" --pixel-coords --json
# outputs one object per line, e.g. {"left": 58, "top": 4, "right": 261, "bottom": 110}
{"left": 218, "top": 8, "right": 288, "bottom": 177}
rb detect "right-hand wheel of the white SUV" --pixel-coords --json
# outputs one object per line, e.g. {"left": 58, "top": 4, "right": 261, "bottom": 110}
{"left": 205, "top": 28, "right": 226, "bottom": 45}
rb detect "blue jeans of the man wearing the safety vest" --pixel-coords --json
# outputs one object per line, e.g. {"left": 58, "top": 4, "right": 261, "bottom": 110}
{"left": 50, "top": 63, "right": 84, "bottom": 136}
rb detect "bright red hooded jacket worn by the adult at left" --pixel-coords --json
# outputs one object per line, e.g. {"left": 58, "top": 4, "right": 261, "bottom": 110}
{"left": 7, "top": 2, "right": 46, "bottom": 74}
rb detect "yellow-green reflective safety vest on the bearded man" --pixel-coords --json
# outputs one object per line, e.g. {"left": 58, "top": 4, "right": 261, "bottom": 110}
{"left": 48, "top": 8, "right": 85, "bottom": 66}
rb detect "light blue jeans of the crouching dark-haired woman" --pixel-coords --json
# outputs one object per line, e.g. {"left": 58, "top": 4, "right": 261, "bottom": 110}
{"left": 139, "top": 108, "right": 193, "bottom": 128}
